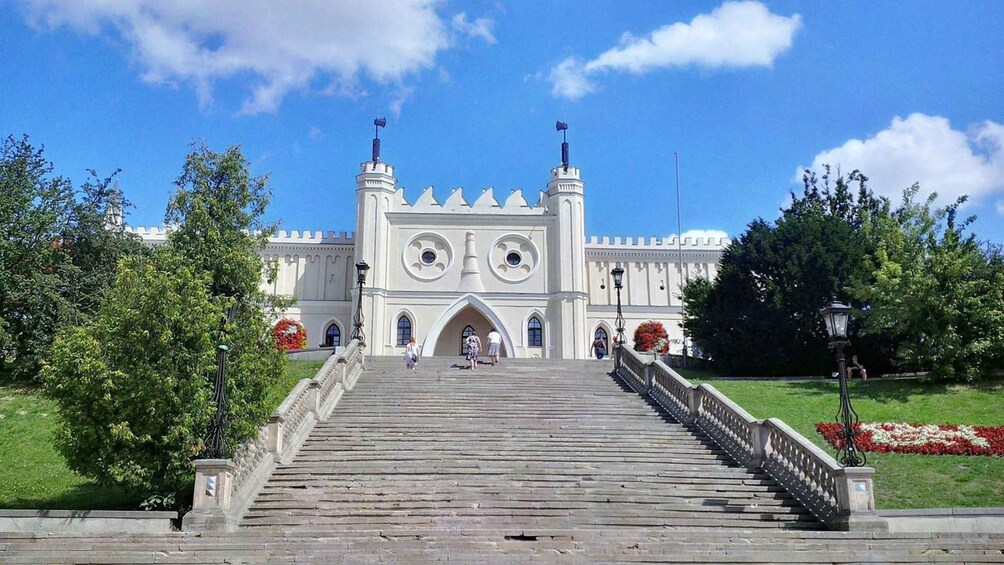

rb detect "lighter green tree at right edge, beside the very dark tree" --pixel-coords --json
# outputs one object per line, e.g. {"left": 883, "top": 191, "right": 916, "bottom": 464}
{"left": 852, "top": 185, "right": 1004, "bottom": 379}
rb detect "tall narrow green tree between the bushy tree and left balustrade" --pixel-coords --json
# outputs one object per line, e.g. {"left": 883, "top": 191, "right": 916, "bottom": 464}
{"left": 165, "top": 146, "right": 289, "bottom": 451}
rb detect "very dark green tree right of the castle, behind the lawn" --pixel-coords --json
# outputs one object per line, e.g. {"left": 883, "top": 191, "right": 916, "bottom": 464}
{"left": 684, "top": 169, "right": 889, "bottom": 374}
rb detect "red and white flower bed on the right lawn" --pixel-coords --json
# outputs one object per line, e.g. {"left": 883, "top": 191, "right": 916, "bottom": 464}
{"left": 816, "top": 422, "right": 1004, "bottom": 456}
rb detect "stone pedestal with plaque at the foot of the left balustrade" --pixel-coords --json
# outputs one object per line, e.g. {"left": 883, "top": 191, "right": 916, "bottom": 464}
{"left": 182, "top": 459, "right": 237, "bottom": 532}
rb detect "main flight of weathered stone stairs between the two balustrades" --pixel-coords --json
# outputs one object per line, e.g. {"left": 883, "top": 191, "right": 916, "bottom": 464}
{"left": 243, "top": 357, "right": 820, "bottom": 531}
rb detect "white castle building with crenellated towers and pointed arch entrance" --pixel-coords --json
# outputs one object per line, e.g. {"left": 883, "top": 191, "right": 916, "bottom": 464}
{"left": 132, "top": 129, "right": 728, "bottom": 359}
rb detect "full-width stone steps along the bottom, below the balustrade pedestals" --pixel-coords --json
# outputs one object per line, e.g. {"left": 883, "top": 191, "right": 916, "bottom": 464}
{"left": 0, "top": 528, "right": 1004, "bottom": 564}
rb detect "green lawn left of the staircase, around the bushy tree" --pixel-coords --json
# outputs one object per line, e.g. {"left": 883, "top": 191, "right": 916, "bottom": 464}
{"left": 0, "top": 361, "right": 323, "bottom": 510}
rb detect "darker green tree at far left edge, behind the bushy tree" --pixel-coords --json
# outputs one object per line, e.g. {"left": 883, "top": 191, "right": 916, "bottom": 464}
{"left": 0, "top": 136, "right": 143, "bottom": 378}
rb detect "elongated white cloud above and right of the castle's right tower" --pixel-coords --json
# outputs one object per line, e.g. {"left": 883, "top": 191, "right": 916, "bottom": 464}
{"left": 550, "top": 1, "right": 801, "bottom": 99}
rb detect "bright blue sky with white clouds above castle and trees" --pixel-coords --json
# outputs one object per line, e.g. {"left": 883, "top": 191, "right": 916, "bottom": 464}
{"left": 0, "top": 0, "right": 1004, "bottom": 243}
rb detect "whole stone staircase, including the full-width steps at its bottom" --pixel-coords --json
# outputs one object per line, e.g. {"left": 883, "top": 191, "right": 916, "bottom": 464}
{"left": 0, "top": 357, "right": 1004, "bottom": 564}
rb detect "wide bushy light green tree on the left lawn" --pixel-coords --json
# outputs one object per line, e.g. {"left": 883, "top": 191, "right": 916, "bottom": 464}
{"left": 41, "top": 248, "right": 221, "bottom": 496}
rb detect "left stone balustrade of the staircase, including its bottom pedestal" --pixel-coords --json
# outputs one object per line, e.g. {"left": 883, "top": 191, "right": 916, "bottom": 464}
{"left": 182, "top": 340, "right": 364, "bottom": 531}
